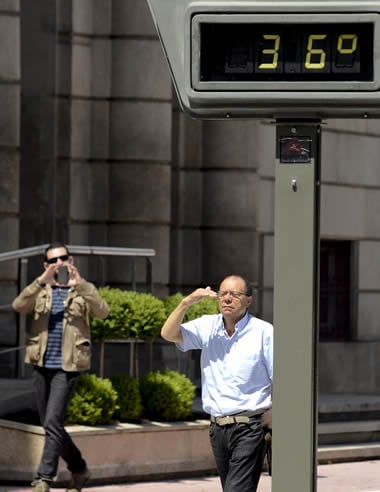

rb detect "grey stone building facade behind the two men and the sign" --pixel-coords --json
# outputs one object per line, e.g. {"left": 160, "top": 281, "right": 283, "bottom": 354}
{"left": 0, "top": 0, "right": 380, "bottom": 393}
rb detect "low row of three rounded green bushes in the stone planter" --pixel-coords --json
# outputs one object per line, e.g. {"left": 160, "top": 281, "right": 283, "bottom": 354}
{"left": 66, "top": 369, "right": 195, "bottom": 426}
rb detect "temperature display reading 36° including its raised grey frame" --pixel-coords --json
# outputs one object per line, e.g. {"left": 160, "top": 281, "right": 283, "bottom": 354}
{"left": 191, "top": 13, "right": 379, "bottom": 93}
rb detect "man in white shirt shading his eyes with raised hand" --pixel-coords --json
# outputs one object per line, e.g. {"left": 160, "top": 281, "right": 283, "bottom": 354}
{"left": 161, "top": 275, "right": 273, "bottom": 492}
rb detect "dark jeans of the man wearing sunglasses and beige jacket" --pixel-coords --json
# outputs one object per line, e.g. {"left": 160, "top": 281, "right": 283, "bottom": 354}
{"left": 33, "top": 366, "right": 86, "bottom": 480}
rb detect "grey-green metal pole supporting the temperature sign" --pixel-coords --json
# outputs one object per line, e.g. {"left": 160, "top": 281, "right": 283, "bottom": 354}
{"left": 272, "top": 121, "right": 321, "bottom": 492}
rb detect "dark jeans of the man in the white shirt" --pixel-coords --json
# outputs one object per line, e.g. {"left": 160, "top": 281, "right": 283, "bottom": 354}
{"left": 210, "top": 416, "right": 265, "bottom": 492}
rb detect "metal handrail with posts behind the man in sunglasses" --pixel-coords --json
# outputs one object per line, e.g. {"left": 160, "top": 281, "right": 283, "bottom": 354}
{"left": 0, "top": 244, "right": 156, "bottom": 377}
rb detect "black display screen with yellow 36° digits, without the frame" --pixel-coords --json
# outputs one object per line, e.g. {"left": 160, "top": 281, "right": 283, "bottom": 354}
{"left": 199, "top": 22, "right": 374, "bottom": 82}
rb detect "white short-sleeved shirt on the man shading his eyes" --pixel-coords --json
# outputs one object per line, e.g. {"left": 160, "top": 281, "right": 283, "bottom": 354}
{"left": 177, "top": 313, "right": 273, "bottom": 417}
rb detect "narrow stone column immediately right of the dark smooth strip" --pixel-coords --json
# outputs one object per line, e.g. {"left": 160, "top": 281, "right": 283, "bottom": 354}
{"left": 59, "top": 1, "right": 112, "bottom": 281}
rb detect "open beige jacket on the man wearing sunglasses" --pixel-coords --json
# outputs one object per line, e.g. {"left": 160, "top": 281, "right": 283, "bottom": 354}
{"left": 12, "top": 279, "right": 109, "bottom": 371}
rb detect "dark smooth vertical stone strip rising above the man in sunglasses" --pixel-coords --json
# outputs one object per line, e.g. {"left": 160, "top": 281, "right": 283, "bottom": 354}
{"left": 19, "top": 0, "right": 57, "bottom": 247}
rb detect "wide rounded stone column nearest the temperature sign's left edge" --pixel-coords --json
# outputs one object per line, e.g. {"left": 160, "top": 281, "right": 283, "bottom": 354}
{"left": 109, "top": 0, "right": 172, "bottom": 295}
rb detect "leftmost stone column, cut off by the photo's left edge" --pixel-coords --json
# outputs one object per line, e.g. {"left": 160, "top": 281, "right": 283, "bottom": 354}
{"left": 0, "top": 0, "right": 21, "bottom": 377}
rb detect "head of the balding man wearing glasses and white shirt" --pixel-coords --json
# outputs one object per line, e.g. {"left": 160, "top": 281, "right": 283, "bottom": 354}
{"left": 218, "top": 277, "right": 252, "bottom": 319}
